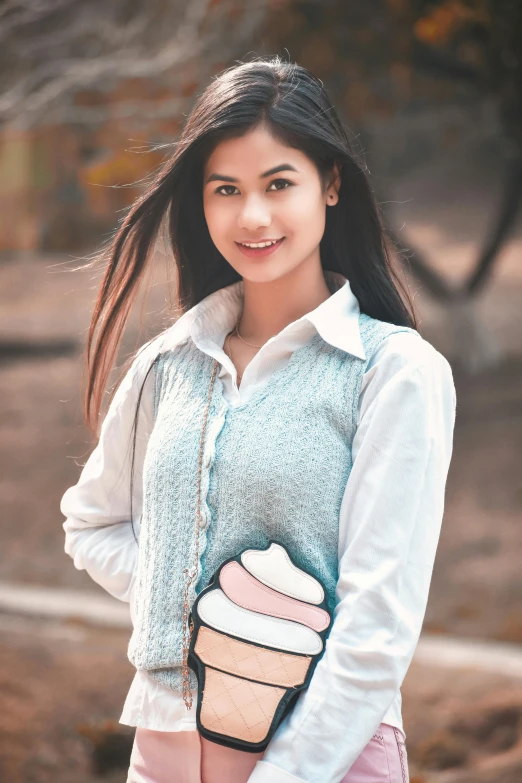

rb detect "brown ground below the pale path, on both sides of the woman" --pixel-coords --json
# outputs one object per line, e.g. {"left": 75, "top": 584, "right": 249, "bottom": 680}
{"left": 0, "top": 616, "right": 522, "bottom": 783}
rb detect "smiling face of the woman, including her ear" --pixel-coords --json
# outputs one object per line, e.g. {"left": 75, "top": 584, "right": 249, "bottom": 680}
{"left": 199, "top": 127, "right": 338, "bottom": 282}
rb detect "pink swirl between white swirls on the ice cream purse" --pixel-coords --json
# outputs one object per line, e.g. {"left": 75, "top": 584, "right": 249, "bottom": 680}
{"left": 219, "top": 561, "right": 330, "bottom": 632}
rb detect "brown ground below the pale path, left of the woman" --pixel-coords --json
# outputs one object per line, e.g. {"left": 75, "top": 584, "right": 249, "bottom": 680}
{"left": 0, "top": 617, "right": 133, "bottom": 783}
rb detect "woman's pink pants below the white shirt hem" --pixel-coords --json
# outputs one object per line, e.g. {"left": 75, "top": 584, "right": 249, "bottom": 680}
{"left": 126, "top": 723, "right": 409, "bottom": 783}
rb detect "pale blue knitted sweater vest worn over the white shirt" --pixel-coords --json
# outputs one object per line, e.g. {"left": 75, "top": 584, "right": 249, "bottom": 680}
{"left": 128, "top": 314, "right": 417, "bottom": 693}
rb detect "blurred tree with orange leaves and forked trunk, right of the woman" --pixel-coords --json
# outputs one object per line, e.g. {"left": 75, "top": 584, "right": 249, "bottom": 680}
{"left": 260, "top": 0, "right": 522, "bottom": 369}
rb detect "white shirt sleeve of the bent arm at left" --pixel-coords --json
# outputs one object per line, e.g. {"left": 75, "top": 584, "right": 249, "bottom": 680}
{"left": 60, "top": 341, "right": 157, "bottom": 601}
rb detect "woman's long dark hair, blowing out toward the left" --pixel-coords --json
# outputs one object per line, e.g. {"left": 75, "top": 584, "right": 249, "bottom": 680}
{"left": 84, "top": 56, "right": 416, "bottom": 544}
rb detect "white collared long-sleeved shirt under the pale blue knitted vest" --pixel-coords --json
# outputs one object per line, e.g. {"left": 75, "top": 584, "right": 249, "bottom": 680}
{"left": 60, "top": 272, "right": 456, "bottom": 783}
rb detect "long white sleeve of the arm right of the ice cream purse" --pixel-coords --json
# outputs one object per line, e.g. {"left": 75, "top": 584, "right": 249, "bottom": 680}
{"left": 249, "top": 333, "right": 456, "bottom": 783}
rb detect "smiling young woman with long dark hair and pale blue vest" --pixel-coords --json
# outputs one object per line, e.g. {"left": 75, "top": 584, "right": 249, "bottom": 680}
{"left": 61, "top": 57, "right": 455, "bottom": 783}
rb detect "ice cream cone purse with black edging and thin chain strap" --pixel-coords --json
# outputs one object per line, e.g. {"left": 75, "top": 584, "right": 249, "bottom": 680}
{"left": 179, "top": 361, "right": 332, "bottom": 752}
